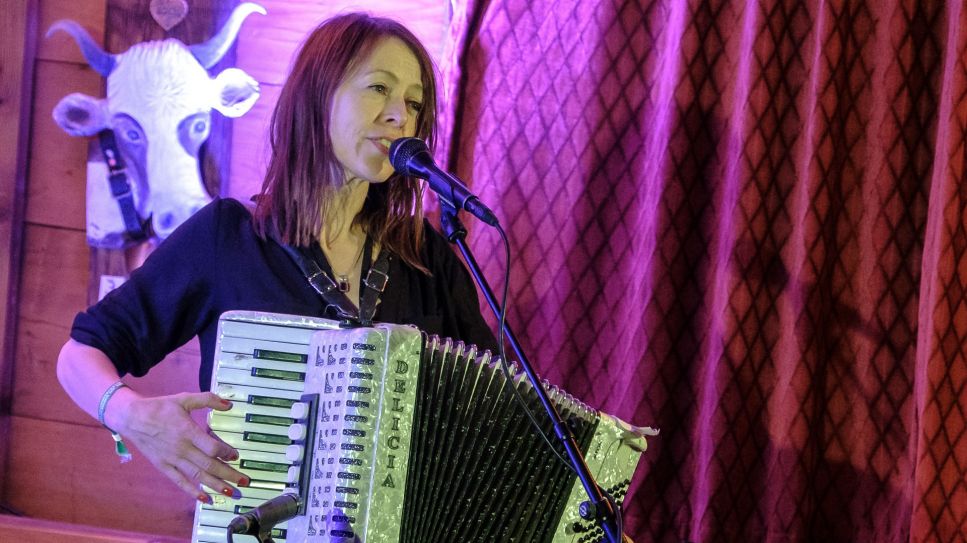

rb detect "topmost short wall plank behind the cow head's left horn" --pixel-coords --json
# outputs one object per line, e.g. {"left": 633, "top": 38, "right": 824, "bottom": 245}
{"left": 37, "top": 0, "right": 107, "bottom": 65}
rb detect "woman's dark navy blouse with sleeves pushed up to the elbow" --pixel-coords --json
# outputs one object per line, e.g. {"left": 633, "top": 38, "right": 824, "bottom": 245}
{"left": 71, "top": 198, "right": 497, "bottom": 390}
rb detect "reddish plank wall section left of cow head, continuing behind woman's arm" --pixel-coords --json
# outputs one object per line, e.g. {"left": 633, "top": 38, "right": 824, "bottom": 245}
{"left": 0, "top": 0, "right": 223, "bottom": 539}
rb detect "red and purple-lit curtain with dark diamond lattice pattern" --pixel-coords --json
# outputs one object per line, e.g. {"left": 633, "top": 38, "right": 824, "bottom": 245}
{"left": 441, "top": 0, "right": 967, "bottom": 542}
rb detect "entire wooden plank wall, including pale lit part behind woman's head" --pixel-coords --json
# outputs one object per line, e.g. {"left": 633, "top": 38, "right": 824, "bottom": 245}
{"left": 0, "top": 0, "right": 446, "bottom": 539}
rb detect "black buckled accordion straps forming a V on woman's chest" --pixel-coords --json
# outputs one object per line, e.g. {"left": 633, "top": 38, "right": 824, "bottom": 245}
{"left": 269, "top": 227, "right": 392, "bottom": 326}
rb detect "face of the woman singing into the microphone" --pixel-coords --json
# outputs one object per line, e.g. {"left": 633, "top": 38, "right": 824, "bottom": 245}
{"left": 329, "top": 37, "right": 423, "bottom": 183}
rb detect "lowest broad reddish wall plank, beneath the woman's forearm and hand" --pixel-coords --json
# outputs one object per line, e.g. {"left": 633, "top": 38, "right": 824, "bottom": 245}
{"left": 5, "top": 416, "right": 194, "bottom": 540}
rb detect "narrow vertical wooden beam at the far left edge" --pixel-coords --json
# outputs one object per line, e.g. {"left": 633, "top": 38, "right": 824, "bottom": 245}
{"left": 0, "top": 0, "right": 38, "bottom": 502}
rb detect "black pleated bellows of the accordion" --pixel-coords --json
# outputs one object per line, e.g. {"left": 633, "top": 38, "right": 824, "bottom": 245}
{"left": 400, "top": 337, "right": 596, "bottom": 543}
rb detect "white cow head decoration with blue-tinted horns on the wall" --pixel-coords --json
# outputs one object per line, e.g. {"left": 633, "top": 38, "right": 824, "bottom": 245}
{"left": 47, "top": 3, "right": 265, "bottom": 249}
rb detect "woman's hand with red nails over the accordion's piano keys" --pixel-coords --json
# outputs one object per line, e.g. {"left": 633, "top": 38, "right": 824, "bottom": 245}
{"left": 104, "top": 388, "right": 250, "bottom": 503}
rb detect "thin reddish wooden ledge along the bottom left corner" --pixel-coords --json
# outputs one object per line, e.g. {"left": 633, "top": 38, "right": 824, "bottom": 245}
{"left": 0, "top": 515, "right": 180, "bottom": 543}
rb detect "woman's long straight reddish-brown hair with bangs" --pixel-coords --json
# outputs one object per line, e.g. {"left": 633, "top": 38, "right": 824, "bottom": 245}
{"left": 255, "top": 13, "right": 437, "bottom": 273}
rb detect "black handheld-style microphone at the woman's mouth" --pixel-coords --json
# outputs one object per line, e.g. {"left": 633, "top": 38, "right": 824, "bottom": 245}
{"left": 389, "top": 138, "right": 498, "bottom": 226}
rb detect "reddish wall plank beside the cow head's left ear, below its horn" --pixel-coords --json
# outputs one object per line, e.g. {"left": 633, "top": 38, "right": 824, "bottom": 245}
{"left": 26, "top": 61, "right": 104, "bottom": 230}
